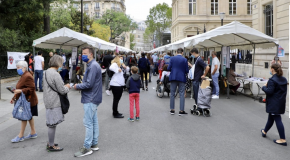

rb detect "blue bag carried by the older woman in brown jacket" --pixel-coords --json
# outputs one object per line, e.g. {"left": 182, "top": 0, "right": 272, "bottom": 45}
{"left": 12, "top": 92, "right": 32, "bottom": 121}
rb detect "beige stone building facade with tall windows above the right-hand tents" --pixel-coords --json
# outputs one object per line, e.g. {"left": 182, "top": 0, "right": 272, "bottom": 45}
{"left": 171, "top": 0, "right": 252, "bottom": 42}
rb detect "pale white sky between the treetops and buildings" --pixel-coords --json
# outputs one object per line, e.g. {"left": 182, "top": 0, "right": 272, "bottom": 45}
{"left": 125, "top": 0, "right": 172, "bottom": 21}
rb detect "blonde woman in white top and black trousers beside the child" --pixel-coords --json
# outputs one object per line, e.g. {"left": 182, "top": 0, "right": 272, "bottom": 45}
{"left": 109, "top": 53, "right": 129, "bottom": 118}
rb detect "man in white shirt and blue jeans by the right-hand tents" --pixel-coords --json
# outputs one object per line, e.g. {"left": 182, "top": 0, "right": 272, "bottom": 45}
{"left": 211, "top": 51, "right": 220, "bottom": 99}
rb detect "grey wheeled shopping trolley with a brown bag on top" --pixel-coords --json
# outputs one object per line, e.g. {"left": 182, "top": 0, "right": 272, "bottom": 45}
{"left": 190, "top": 78, "right": 212, "bottom": 117}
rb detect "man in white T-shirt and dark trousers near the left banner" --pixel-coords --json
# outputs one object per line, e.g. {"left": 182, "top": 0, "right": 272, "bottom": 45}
{"left": 34, "top": 51, "right": 44, "bottom": 92}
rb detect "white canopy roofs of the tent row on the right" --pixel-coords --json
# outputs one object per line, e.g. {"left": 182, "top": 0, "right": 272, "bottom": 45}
{"left": 150, "top": 21, "right": 279, "bottom": 53}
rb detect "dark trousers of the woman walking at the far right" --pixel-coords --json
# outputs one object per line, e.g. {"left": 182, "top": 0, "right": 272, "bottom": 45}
{"left": 264, "top": 113, "right": 286, "bottom": 139}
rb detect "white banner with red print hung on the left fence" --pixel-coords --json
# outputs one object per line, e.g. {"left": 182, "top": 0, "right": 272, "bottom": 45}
{"left": 7, "top": 52, "right": 28, "bottom": 69}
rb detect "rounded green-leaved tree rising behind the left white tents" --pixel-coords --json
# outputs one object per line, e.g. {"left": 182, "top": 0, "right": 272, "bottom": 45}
{"left": 97, "top": 10, "right": 134, "bottom": 42}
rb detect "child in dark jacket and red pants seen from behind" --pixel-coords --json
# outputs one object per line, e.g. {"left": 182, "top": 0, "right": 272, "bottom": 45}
{"left": 126, "top": 66, "right": 141, "bottom": 122}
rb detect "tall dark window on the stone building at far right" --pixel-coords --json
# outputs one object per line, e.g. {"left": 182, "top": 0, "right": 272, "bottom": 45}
{"left": 264, "top": 4, "right": 273, "bottom": 37}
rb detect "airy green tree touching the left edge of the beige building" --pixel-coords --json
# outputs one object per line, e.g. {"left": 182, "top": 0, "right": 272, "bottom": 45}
{"left": 146, "top": 3, "right": 172, "bottom": 46}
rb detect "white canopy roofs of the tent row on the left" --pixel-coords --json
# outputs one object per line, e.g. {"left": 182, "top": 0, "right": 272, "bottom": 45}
{"left": 32, "top": 27, "right": 133, "bottom": 52}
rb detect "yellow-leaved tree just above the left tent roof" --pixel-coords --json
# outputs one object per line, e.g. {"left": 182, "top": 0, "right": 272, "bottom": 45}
{"left": 90, "top": 22, "right": 110, "bottom": 42}
